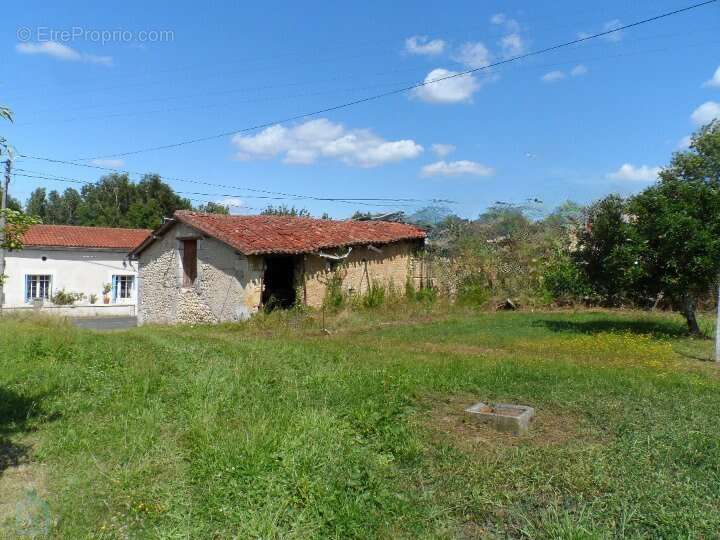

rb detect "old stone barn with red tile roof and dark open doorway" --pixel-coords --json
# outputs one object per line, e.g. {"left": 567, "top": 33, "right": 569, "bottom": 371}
{"left": 130, "top": 210, "right": 425, "bottom": 324}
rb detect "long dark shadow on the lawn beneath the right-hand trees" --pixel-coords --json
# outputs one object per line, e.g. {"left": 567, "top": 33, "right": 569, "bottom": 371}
{"left": 533, "top": 319, "right": 689, "bottom": 338}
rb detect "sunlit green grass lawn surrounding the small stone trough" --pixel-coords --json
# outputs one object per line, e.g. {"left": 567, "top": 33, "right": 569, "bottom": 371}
{"left": 0, "top": 312, "right": 720, "bottom": 539}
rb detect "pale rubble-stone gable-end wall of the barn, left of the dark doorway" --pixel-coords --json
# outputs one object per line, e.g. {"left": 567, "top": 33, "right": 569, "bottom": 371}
{"left": 138, "top": 224, "right": 263, "bottom": 324}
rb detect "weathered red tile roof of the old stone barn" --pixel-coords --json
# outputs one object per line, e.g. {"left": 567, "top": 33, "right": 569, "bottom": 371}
{"left": 175, "top": 210, "right": 425, "bottom": 255}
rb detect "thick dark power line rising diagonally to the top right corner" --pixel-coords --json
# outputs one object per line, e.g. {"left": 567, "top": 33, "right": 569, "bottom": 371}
{"left": 80, "top": 0, "right": 718, "bottom": 161}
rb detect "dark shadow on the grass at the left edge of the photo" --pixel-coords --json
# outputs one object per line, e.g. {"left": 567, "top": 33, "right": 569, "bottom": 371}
{"left": 0, "top": 387, "right": 57, "bottom": 475}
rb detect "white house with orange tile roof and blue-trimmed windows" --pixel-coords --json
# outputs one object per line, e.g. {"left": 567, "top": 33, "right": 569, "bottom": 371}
{"left": 0, "top": 225, "right": 150, "bottom": 316}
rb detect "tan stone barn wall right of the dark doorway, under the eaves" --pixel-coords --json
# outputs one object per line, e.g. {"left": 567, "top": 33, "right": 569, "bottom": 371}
{"left": 298, "top": 241, "right": 418, "bottom": 307}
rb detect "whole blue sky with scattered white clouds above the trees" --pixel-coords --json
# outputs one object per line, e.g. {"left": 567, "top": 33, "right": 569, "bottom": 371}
{"left": 0, "top": 0, "right": 720, "bottom": 217}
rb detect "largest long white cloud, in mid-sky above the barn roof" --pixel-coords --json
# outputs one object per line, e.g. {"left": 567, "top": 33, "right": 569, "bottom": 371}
{"left": 232, "top": 118, "right": 423, "bottom": 167}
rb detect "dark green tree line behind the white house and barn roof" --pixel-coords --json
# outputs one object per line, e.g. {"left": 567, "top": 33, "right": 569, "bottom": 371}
{"left": 25, "top": 173, "right": 229, "bottom": 229}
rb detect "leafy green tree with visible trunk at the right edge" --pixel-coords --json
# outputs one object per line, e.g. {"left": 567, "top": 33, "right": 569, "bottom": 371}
{"left": 630, "top": 121, "right": 720, "bottom": 334}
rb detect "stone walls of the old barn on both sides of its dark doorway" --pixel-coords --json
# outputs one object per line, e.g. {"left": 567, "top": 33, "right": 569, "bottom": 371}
{"left": 138, "top": 223, "right": 419, "bottom": 324}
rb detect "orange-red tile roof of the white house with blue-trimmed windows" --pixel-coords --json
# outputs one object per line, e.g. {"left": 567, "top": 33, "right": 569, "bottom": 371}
{"left": 23, "top": 225, "right": 152, "bottom": 250}
